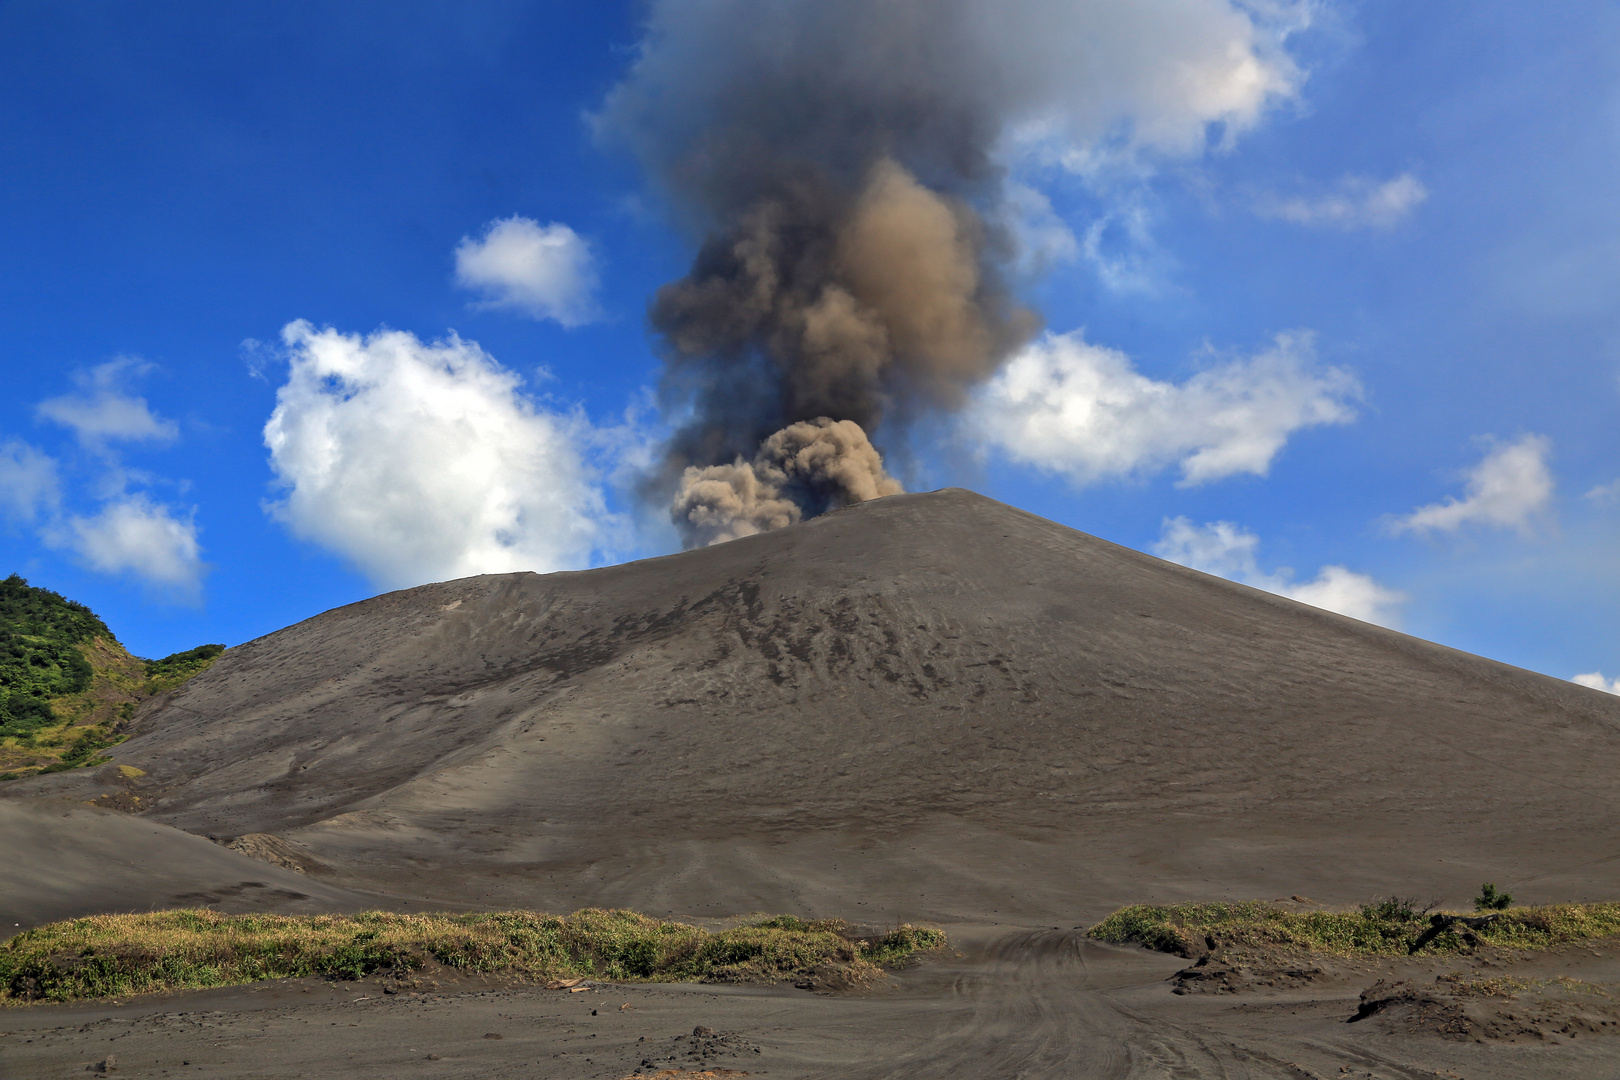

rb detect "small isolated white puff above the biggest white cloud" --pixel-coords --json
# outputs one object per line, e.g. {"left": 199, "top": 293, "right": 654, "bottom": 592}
{"left": 455, "top": 217, "right": 596, "bottom": 327}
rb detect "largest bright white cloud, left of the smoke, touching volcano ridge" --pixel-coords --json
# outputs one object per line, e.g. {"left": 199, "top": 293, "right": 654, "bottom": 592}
{"left": 264, "top": 321, "right": 608, "bottom": 588}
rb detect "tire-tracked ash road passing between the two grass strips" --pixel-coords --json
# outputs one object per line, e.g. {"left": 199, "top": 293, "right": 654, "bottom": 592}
{"left": 846, "top": 931, "right": 1334, "bottom": 1080}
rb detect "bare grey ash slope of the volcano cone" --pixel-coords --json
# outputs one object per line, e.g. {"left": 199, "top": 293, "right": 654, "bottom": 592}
{"left": 12, "top": 489, "right": 1620, "bottom": 921}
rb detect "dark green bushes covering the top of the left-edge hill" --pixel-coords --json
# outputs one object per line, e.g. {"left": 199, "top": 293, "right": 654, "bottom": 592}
{"left": 0, "top": 573, "right": 113, "bottom": 738}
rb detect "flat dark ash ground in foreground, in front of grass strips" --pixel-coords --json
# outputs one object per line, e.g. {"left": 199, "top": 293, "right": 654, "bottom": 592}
{"left": 9, "top": 926, "right": 1620, "bottom": 1080}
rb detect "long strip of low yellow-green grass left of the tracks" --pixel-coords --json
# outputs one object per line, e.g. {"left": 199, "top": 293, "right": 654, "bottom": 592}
{"left": 0, "top": 908, "right": 944, "bottom": 1004}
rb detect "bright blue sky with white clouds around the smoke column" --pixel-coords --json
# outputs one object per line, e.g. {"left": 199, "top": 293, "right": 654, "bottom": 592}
{"left": 0, "top": 0, "right": 1620, "bottom": 693}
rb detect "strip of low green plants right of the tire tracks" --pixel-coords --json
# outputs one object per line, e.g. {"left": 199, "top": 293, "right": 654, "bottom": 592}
{"left": 1087, "top": 900, "right": 1620, "bottom": 955}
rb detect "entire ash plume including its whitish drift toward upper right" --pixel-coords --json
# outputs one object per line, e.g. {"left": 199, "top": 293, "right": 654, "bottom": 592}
{"left": 596, "top": 0, "right": 1291, "bottom": 544}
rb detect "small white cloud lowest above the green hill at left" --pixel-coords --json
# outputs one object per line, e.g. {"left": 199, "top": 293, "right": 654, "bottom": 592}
{"left": 59, "top": 494, "right": 204, "bottom": 596}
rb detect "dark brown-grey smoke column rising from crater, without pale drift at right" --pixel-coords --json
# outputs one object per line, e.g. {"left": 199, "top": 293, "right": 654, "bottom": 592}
{"left": 598, "top": 0, "right": 1038, "bottom": 546}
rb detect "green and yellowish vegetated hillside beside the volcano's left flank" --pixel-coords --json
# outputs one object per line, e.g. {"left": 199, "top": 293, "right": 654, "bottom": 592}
{"left": 0, "top": 573, "right": 225, "bottom": 780}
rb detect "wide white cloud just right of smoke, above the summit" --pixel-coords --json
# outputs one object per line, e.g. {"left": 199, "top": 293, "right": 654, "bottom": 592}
{"left": 966, "top": 332, "right": 1359, "bottom": 486}
